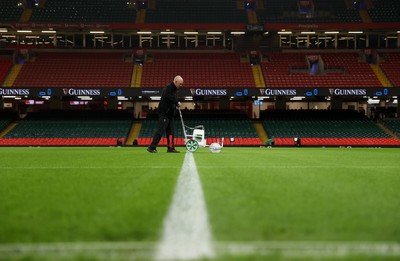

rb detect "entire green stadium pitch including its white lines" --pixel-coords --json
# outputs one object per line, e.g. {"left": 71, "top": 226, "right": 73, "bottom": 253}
{"left": 0, "top": 147, "right": 400, "bottom": 261}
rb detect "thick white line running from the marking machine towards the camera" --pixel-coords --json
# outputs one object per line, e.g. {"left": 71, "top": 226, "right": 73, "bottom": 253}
{"left": 155, "top": 152, "right": 215, "bottom": 260}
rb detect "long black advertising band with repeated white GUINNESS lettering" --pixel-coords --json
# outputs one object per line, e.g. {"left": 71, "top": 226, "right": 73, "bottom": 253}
{"left": 0, "top": 87, "right": 400, "bottom": 97}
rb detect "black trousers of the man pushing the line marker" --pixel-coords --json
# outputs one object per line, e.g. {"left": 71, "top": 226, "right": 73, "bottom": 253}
{"left": 150, "top": 115, "right": 175, "bottom": 149}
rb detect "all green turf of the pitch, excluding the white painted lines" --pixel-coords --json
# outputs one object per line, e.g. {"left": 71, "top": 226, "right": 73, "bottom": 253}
{"left": 0, "top": 147, "right": 400, "bottom": 261}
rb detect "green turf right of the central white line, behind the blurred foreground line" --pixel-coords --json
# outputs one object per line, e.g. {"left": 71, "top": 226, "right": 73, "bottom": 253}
{"left": 196, "top": 148, "right": 400, "bottom": 241}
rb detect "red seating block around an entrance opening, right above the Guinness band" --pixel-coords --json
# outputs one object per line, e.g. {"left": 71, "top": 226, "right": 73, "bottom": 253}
{"left": 262, "top": 52, "right": 382, "bottom": 88}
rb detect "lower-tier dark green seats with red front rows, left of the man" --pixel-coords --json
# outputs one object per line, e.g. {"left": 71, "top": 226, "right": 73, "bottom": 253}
{"left": 0, "top": 111, "right": 131, "bottom": 146}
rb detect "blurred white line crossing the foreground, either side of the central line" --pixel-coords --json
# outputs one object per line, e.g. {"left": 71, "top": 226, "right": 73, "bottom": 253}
{"left": 0, "top": 241, "right": 400, "bottom": 261}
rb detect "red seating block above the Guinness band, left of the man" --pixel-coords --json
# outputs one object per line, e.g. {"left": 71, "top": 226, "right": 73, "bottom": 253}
{"left": 13, "top": 52, "right": 133, "bottom": 88}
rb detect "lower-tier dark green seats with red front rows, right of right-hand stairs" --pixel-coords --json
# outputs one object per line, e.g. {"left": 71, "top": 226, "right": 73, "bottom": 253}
{"left": 262, "top": 110, "right": 400, "bottom": 146}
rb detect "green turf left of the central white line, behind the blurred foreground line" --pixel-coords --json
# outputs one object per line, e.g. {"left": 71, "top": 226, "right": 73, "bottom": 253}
{"left": 0, "top": 148, "right": 182, "bottom": 243}
